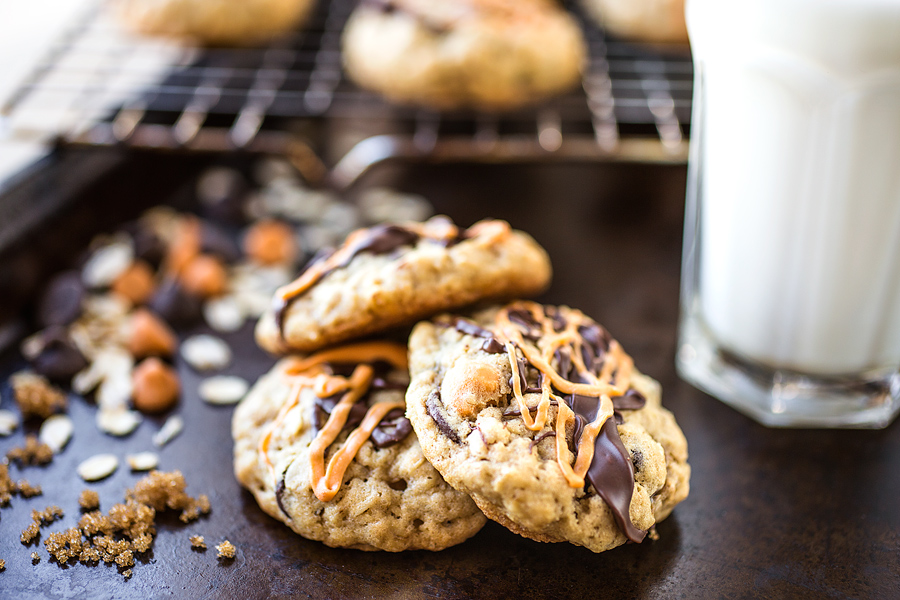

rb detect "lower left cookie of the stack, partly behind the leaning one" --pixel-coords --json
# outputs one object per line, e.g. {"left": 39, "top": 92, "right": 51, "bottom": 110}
{"left": 232, "top": 342, "right": 485, "bottom": 552}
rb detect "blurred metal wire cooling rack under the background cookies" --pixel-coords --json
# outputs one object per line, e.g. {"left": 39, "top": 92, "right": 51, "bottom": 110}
{"left": 0, "top": 0, "right": 693, "bottom": 186}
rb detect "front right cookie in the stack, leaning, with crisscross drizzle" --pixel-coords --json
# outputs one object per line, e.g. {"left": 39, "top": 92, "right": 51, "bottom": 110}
{"left": 406, "top": 301, "right": 690, "bottom": 552}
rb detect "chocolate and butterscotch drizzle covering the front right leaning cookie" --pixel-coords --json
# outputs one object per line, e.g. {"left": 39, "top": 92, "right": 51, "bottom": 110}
{"left": 472, "top": 302, "right": 646, "bottom": 543}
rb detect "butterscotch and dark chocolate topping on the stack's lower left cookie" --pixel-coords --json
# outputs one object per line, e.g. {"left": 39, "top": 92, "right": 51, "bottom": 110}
{"left": 258, "top": 342, "right": 412, "bottom": 506}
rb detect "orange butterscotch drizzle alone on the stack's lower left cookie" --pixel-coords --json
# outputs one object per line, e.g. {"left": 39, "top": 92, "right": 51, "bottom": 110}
{"left": 257, "top": 342, "right": 407, "bottom": 502}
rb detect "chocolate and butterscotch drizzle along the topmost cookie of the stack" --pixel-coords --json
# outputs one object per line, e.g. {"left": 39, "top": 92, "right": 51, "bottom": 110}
{"left": 273, "top": 218, "right": 509, "bottom": 339}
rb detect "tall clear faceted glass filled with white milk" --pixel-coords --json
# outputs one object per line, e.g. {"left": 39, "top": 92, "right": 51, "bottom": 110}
{"left": 677, "top": 0, "right": 900, "bottom": 427}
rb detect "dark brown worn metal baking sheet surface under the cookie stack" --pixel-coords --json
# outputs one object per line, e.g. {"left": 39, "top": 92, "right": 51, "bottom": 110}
{"left": 0, "top": 151, "right": 900, "bottom": 599}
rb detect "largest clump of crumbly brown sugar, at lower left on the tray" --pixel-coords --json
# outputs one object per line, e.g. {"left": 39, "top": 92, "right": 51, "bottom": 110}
{"left": 44, "top": 471, "right": 210, "bottom": 579}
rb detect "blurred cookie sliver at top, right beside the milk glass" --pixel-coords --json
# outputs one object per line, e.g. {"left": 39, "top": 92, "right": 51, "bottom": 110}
{"left": 581, "top": 0, "right": 688, "bottom": 44}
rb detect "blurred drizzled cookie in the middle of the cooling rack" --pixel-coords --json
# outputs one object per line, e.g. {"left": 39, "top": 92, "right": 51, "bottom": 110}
{"left": 343, "top": 0, "right": 585, "bottom": 110}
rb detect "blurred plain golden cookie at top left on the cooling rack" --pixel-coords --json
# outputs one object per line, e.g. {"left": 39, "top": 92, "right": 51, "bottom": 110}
{"left": 115, "top": 0, "right": 315, "bottom": 45}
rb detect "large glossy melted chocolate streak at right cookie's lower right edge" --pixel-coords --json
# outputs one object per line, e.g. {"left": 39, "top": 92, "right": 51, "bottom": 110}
{"left": 587, "top": 419, "right": 647, "bottom": 544}
